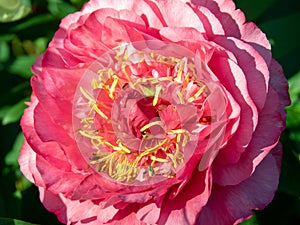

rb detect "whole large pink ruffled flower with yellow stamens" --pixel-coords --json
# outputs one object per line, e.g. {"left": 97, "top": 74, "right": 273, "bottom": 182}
{"left": 19, "top": 0, "right": 289, "bottom": 225}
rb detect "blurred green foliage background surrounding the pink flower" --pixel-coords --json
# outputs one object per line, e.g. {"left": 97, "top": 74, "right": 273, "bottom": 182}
{"left": 0, "top": 0, "right": 300, "bottom": 225}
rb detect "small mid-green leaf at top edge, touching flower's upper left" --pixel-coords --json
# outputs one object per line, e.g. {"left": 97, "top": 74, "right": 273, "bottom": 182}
{"left": 48, "top": 0, "right": 77, "bottom": 18}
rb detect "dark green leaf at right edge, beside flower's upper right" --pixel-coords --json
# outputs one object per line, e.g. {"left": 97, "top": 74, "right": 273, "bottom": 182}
{"left": 260, "top": 13, "right": 300, "bottom": 58}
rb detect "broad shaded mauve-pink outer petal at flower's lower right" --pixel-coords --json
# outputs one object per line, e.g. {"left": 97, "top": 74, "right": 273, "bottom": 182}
{"left": 197, "top": 145, "right": 281, "bottom": 225}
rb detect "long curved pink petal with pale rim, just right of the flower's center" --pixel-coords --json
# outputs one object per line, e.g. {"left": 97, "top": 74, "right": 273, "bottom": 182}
{"left": 209, "top": 54, "right": 258, "bottom": 164}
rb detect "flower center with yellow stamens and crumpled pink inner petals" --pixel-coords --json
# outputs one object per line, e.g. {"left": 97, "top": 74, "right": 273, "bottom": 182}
{"left": 73, "top": 41, "right": 211, "bottom": 185}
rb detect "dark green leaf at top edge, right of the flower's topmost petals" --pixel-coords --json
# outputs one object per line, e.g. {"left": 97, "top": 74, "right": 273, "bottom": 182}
{"left": 235, "top": 0, "right": 275, "bottom": 21}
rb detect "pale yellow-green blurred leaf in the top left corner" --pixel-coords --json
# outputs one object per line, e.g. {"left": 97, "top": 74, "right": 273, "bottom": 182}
{"left": 0, "top": 0, "right": 31, "bottom": 23}
